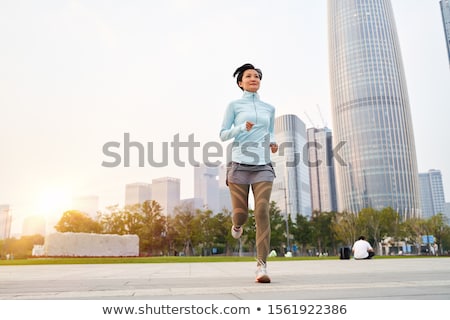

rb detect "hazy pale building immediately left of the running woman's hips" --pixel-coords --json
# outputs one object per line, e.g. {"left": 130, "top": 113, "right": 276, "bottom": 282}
{"left": 194, "top": 164, "right": 221, "bottom": 213}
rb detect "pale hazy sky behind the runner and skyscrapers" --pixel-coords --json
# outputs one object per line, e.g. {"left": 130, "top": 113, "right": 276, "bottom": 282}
{"left": 0, "top": 0, "right": 450, "bottom": 233}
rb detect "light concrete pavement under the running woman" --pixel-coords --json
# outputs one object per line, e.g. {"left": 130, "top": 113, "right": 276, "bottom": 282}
{"left": 0, "top": 257, "right": 450, "bottom": 300}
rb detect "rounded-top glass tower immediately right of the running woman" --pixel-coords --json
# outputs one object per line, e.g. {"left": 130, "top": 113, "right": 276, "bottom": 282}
{"left": 271, "top": 114, "right": 312, "bottom": 219}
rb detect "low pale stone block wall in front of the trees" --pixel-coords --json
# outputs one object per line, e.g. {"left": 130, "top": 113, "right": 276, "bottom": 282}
{"left": 43, "top": 232, "right": 139, "bottom": 257}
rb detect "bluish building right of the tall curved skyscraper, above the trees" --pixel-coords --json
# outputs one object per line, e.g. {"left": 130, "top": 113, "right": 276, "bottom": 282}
{"left": 419, "top": 169, "right": 445, "bottom": 218}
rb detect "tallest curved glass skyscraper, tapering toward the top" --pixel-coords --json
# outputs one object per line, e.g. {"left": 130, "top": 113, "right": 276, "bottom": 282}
{"left": 328, "top": 0, "right": 420, "bottom": 219}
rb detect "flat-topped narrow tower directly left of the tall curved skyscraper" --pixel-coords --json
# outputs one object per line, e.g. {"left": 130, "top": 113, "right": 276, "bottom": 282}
{"left": 307, "top": 127, "right": 337, "bottom": 212}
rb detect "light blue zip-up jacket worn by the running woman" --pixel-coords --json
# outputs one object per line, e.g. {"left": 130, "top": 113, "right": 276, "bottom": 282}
{"left": 220, "top": 91, "right": 275, "bottom": 165}
